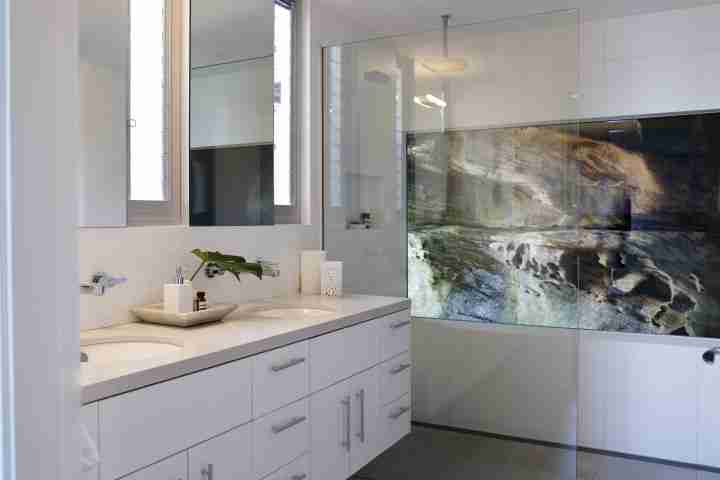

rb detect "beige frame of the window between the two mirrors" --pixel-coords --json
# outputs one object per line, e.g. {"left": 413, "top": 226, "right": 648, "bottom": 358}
{"left": 127, "top": 0, "right": 189, "bottom": 226}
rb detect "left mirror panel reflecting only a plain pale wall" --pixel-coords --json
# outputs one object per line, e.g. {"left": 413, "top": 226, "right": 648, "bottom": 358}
{"left": 78, "top": 0, "right": 130, "bottom": 226}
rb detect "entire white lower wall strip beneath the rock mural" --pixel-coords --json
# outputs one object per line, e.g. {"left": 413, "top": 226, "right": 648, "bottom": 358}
{"left": 413, "top": 319, "right": 720, "bottom": 467}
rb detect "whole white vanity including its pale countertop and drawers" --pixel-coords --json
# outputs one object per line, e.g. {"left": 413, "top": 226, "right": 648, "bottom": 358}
{"left": 81, "top": 295, "right": 411, "bottom": 480}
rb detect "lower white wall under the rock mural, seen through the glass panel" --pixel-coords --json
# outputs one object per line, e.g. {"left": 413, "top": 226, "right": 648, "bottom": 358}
{"left": 412, "top": 318, "right": 578, "bottom": 445}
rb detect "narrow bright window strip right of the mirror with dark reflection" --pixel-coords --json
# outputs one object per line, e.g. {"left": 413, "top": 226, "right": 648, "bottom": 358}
{"left": 273, "top": 0, "right": 295, "bottom": 207}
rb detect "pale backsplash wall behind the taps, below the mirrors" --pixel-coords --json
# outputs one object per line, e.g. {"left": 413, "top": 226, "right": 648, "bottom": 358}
{"left": 78, "top": 225, "right": 320, "bottom": 330}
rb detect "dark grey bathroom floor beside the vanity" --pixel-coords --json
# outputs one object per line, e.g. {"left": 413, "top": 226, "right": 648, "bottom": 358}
{"left": 355, "top": 427, "right": 720, "bottom": 480}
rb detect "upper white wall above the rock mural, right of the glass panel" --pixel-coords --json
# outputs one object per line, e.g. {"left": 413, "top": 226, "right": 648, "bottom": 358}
{"left": 579, "top": 4, "right": 720, "bottom": 118}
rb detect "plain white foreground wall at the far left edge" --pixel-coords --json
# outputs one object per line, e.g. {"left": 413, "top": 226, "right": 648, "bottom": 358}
{"left": 0, "top": 0, "right": 80, "bottom": 480}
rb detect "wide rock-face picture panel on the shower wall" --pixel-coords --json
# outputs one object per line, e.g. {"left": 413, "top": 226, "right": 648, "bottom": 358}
{"left": 407, "top": 113, "right": 720, "bottom": 337}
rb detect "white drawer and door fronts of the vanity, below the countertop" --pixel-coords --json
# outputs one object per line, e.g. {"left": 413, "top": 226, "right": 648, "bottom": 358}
{"left": 91, "top": 310, "right": 411, "bottom": 480}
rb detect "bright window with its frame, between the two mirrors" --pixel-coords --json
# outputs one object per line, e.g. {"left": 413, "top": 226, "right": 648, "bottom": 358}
{"left": 128, "top": 0, "right": 182, "bottom": 224}
